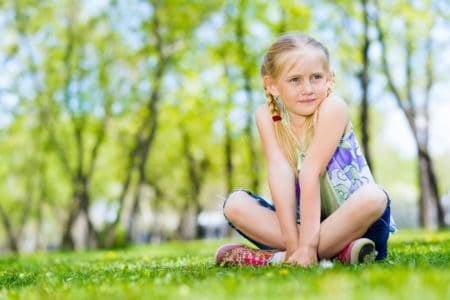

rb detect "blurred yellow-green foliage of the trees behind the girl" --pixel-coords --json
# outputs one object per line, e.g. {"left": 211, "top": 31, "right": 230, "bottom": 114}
{"left": 0, "top": 0, "right": 449, "bottom": 248}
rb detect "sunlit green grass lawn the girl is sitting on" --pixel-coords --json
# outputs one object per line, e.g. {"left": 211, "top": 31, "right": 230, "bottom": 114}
{"left": 0, "top": 231, "right": 450, "bottom": 300}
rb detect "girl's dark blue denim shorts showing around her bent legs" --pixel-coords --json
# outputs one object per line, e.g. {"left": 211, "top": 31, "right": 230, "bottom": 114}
{"left": 223, "top": 190, "right": 391, "bottom": 260}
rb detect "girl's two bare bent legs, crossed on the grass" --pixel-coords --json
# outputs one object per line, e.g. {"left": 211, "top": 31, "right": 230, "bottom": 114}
{"left": 224, "top": 184, "right": 387, "bottom": 258}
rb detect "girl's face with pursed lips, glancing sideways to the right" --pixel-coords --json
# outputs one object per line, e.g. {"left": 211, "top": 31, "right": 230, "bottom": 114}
{"left": 269, "top": 47, "right": 331, "bottom": 117}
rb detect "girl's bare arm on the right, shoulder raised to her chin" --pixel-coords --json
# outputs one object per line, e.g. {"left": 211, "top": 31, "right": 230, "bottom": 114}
{"left": 290, "top": 97, "right": 348, "bottom": 265}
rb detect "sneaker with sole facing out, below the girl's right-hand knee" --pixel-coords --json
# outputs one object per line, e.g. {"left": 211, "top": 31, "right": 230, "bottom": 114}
{"left": 336, "top": 238, "right": 377, "bottom": 264}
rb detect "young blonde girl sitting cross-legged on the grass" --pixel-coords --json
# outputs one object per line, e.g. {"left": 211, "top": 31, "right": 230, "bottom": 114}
{"left": 216, "top": 34, "right": 390, "bottom": 266}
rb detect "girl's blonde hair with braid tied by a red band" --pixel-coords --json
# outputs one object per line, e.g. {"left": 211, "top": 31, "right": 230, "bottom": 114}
{"left": 261, "top": 33, "right": 330, "bottom": 170}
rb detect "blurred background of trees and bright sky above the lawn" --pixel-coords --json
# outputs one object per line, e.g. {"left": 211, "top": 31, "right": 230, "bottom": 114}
{"left": 0, "top": 0, "right": 450, "bottom": 252}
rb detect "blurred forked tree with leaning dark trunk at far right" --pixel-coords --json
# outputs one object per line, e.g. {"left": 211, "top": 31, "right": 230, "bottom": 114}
{"left": 375, "top": 1, "right": 445, "bottom": 227}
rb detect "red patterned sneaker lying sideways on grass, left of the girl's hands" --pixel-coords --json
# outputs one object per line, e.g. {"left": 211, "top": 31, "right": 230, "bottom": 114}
{"left": 215, "top": 244, "right": 275, "bottom": 267}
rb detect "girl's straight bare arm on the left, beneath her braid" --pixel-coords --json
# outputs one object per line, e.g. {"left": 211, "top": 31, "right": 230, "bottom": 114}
{"left": 256, "top": 105, "right": 298, "bottom": 255}
